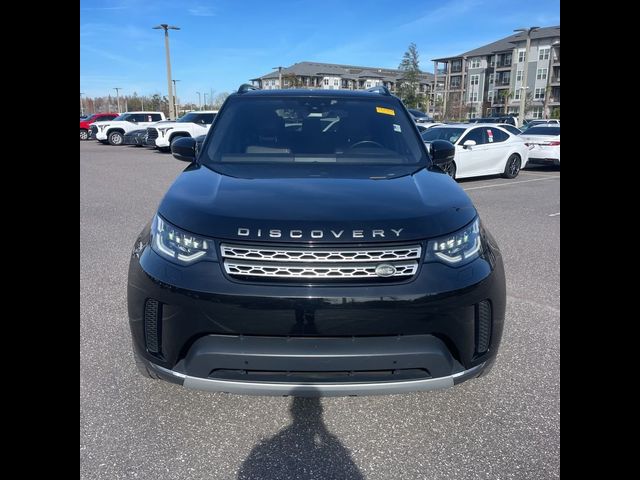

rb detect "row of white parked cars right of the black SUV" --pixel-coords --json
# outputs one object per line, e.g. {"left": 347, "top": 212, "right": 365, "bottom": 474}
{"left": 420, "top": 123, "right": 560, "bottom": 179}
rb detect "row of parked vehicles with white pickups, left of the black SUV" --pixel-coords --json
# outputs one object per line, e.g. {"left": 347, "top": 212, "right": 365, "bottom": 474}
{"left": 80, "top": 110, "right": 218, "bottom": 151}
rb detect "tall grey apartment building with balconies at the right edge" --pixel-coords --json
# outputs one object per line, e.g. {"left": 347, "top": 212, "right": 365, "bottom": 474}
{"left": 432, "top": 26, "right": 560, "bottom": 122}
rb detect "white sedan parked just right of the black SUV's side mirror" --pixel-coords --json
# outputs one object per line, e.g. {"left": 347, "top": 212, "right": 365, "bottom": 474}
{"left": 420, "top": 123, "right": 529, "bottom": 178}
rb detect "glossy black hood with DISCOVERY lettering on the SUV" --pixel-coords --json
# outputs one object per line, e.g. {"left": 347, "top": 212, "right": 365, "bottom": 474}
{"left": 158, "top": 164, "right": 476, "bottom": 243}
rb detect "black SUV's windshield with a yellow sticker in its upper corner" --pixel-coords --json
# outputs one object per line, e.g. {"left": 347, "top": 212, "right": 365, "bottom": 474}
{"left": 201, "top": 96, "right": 427, "bottom": 166}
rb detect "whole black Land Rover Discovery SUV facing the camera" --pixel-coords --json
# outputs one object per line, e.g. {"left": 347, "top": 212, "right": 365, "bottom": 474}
{"left": 128, "top": 86, "right": 506, "bottom": 396}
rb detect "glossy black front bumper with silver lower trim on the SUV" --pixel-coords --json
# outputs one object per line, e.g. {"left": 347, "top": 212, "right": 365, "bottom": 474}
{"left": 128, "top": 230, "right": 505, "bottom": 396}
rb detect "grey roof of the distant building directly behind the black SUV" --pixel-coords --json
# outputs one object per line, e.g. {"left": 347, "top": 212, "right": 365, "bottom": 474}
{"left": 251, "top": 62, "right": 433, "bottom": 82}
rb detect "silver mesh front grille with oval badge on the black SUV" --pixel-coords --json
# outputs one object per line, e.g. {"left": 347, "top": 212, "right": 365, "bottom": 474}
{"left": 220, "top": 244, "right": 422, "bottom": 282}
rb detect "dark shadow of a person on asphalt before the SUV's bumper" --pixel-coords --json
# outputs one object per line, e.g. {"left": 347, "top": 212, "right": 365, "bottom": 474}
{"left": 238, "top": 391, "right": 365, "bottom": 480}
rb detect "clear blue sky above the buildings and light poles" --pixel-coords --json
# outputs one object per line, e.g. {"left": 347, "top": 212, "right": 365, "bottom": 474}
{"left": 80, "top": 0, "right": 560, "bottom": 102}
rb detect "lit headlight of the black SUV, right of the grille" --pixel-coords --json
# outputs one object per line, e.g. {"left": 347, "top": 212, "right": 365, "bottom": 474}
{"left": 425, "top": 217, "right": 482, "bottom": 267}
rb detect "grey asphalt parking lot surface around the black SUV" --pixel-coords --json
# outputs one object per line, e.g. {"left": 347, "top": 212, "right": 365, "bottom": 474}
{"left": 80, "top": 141, "right": 560, "bottom": 480}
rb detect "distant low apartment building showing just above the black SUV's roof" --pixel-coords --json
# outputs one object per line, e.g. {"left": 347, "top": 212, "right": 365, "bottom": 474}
{"left": 250, "top": 62, "right": 433, "bottom": 96}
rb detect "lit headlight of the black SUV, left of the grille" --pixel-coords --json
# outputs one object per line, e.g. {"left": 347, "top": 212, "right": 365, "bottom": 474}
{"left": 151, "top": 215, "right": 216, "bottom": 265}
